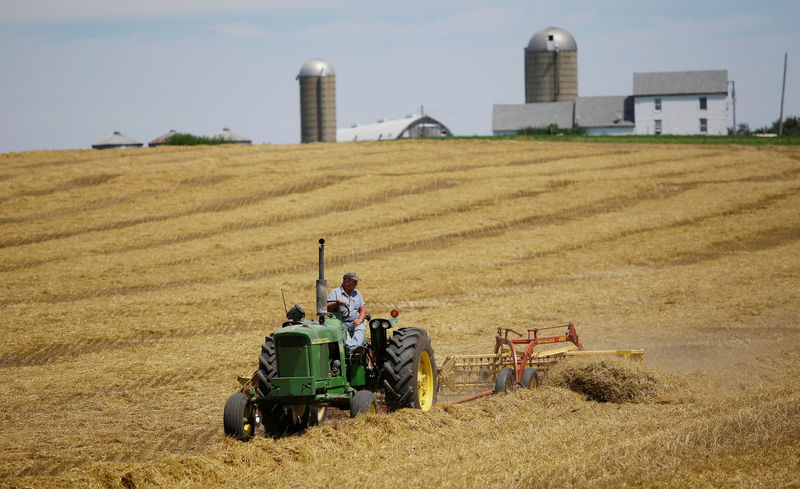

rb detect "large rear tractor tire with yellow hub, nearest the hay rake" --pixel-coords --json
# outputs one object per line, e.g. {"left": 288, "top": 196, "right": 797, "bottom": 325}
{"left": 382, "top": 328, "right": 437, "bottom": 411}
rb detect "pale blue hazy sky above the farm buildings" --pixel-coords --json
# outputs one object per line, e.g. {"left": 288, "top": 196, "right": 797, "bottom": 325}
{"left": 0, "top": 0, "right": 800, "bottom": 153}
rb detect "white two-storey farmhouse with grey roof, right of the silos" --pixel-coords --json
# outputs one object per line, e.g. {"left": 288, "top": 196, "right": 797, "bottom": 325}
{"left": 633, "top": 70, "right": 728, "bottom": 136}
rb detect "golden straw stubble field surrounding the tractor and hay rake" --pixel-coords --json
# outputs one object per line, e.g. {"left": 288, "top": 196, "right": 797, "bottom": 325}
{"left": 0, "top": 140, "right": 800, "bottom": 488}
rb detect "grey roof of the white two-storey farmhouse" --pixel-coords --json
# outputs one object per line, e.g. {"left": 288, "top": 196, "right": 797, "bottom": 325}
{"left": 633, "top": 70, "right": 728, "bottom": 97}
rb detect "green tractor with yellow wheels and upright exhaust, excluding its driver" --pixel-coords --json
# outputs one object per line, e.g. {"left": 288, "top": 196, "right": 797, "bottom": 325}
{"left": 223, "top": 239, "right": 437, "bottom": 441}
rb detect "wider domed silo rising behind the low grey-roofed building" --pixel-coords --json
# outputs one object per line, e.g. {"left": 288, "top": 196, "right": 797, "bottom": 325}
{"left": 525, "top": 27, "right": 578, "bottom": 104}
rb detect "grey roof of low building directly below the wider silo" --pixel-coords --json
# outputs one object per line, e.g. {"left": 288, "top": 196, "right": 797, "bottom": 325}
{"left": 492, "top": 102, "right": 574, "bottom": 132}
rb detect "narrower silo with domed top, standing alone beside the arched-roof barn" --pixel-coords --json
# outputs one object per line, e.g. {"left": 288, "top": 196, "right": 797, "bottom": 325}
{"left": 297, "top": 59, "right": 336, "bottom": 143}
